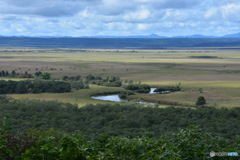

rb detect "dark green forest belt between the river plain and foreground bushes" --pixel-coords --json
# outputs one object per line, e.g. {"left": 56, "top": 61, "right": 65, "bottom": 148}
{"left": 0, "top": 96, "right": 240, "bottom": 137}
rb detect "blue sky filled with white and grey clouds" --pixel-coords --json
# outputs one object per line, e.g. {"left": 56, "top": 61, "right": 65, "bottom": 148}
{"left": 0, "top": 0, "right": 240, "bottom": 37}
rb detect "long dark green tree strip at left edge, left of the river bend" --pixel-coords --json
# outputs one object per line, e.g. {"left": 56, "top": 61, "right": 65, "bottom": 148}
{"left": 0, "top": 80, "right": 71, "bottom": 94}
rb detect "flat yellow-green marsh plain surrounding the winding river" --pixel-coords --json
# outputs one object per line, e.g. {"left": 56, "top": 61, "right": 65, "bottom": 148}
{"left": 0, "top": 48, "right": 240, "bottom": 107}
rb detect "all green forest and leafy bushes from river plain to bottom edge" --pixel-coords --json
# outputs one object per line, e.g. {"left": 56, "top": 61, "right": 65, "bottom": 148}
{"left": 0, "top": 96, "right": 240, "bottom": 160}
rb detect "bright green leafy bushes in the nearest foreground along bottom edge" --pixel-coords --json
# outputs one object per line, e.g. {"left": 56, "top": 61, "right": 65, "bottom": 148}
{"left": 0, "top": 120, "right": 240, "bottom": 160}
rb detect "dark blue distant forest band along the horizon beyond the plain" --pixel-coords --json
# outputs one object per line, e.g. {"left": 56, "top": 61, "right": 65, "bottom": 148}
{"left": 0, "top": 37, "right": 240, "bottom": 49}
